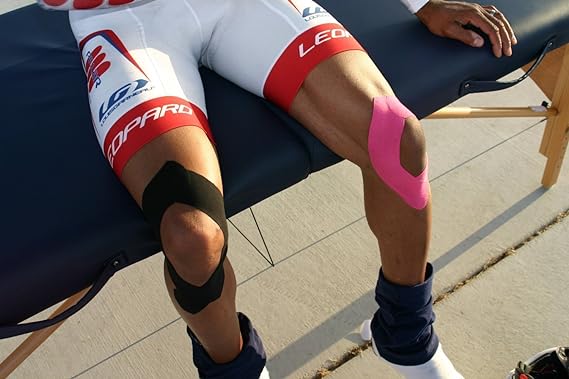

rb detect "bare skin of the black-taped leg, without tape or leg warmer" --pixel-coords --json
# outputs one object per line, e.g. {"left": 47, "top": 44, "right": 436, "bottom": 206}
{"left": 121, "top": 127, "right": 242, "bottom": 363}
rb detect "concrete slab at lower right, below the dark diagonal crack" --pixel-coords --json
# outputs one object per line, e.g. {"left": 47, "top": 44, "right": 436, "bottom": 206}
{"left": 330, "top": 213, "right": 569, "bottom": 379}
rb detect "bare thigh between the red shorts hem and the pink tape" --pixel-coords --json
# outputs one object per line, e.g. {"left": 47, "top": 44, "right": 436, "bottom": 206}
{"left": 289, "top": 51, "right": 393, "bottom": 166}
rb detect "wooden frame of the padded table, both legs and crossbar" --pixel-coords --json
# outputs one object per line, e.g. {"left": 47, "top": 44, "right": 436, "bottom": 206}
{"left": 0, "top": 47, "right": 569, "bottom": 378}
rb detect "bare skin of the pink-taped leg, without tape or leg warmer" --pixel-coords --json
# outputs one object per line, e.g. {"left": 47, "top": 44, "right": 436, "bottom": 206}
{"left": 289, "top": 51, "right": 431, "bottom": 286}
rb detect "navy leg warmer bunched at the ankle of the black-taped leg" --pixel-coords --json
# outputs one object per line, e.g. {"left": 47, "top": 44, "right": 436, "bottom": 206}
{"left": 187, "top": 313, "right": 270, "bottom": 379}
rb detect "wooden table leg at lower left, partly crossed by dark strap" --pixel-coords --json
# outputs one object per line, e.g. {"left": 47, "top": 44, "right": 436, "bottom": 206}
{"left": 0, "top": 288, "right": 89, "bottom": 378}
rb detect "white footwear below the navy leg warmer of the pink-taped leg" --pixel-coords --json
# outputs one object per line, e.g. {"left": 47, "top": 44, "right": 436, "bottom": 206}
{"left": 360, "top": 320, "right": 464, "bottom": 379}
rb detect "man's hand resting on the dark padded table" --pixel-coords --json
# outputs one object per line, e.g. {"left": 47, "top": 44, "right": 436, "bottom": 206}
{"left": 416, "top": 0, "right": 518, "bottom": 58}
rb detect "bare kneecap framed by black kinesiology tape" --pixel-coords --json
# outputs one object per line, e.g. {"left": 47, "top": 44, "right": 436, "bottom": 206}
{"left": 160, "top": 204, "right": 225, "bottom": 286}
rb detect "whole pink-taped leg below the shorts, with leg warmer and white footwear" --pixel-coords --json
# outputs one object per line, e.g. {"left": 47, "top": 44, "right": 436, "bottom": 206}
{"left": 289, "top": 51, "right": 461, "bottom": 378}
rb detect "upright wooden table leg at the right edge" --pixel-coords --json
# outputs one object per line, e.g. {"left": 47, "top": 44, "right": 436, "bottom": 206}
{"left": 539, "top": 49, "right": 569, "bottom": 188}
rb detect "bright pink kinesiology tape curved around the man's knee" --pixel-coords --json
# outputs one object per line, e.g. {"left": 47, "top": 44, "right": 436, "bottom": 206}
{"left": 368, "top": 96, "right": 429, "bottom": 209}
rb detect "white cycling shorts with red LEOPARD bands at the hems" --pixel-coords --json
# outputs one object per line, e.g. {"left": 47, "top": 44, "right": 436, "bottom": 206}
{"left": 69, "top": 0, "right": 363, "bottom": 176}
